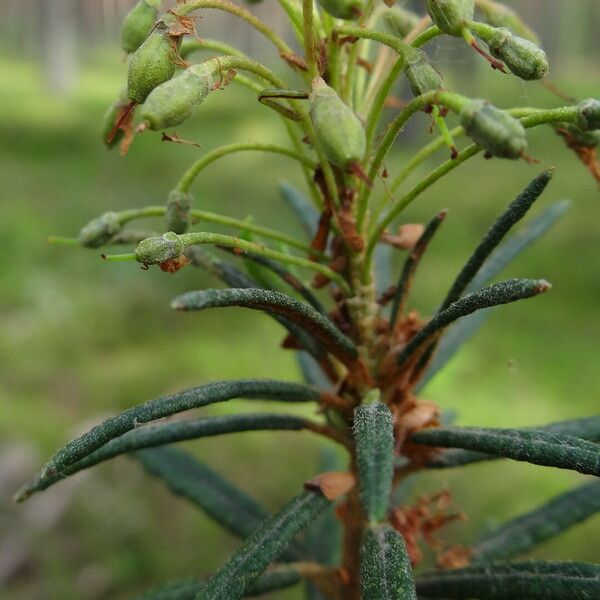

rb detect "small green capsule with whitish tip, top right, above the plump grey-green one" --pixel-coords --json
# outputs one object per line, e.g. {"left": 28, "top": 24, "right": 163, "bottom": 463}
{"left": 488, "top": 27, "right": 548, "bottom": 81}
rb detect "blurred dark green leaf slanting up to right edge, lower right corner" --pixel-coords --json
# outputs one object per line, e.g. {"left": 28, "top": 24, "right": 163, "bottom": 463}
{"left": 471, "top": 481, "right": 600, "bottom": 563}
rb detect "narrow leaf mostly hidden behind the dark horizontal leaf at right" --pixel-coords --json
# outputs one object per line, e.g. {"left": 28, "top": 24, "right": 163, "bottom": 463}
{"left": 427, "top": 416, "right": 600, "bottom": 469}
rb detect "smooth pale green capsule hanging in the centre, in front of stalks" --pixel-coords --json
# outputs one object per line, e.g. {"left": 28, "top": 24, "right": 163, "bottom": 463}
{"left": 310, "top": 77, "right": 367, "bottom": 169}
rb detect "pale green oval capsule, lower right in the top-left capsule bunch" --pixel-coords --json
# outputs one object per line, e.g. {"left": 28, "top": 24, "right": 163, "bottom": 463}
{"left": 141, "top": 64, "right": 213, "bottom": 131}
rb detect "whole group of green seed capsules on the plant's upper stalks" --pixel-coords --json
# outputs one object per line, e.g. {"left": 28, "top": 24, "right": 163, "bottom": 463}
{"left": 95, "top": 0, "right": 600, "bottom": 264}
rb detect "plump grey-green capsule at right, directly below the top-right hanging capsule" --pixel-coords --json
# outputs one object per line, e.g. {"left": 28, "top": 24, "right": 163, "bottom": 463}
{"left": 460, "top": 100, "right": 527, "bottom": 159}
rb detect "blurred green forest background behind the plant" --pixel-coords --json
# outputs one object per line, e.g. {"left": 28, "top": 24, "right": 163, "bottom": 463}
{"left": 0, "top": 0, "right": 600, "bottom": 600}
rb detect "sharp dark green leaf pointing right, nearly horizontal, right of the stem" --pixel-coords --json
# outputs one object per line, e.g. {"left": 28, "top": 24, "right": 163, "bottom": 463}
{"left": 411, "top": 427, "right": 600, "bottom": 476}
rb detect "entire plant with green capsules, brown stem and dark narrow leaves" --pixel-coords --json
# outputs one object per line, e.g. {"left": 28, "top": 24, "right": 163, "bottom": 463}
{"left": 21, "top": 0, "right": 600, "bottom": 600}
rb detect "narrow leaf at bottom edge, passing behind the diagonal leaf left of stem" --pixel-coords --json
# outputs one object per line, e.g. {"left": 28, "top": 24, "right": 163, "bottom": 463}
{"left": 136, "top": 565, "right": 300, "bottom": 600}
